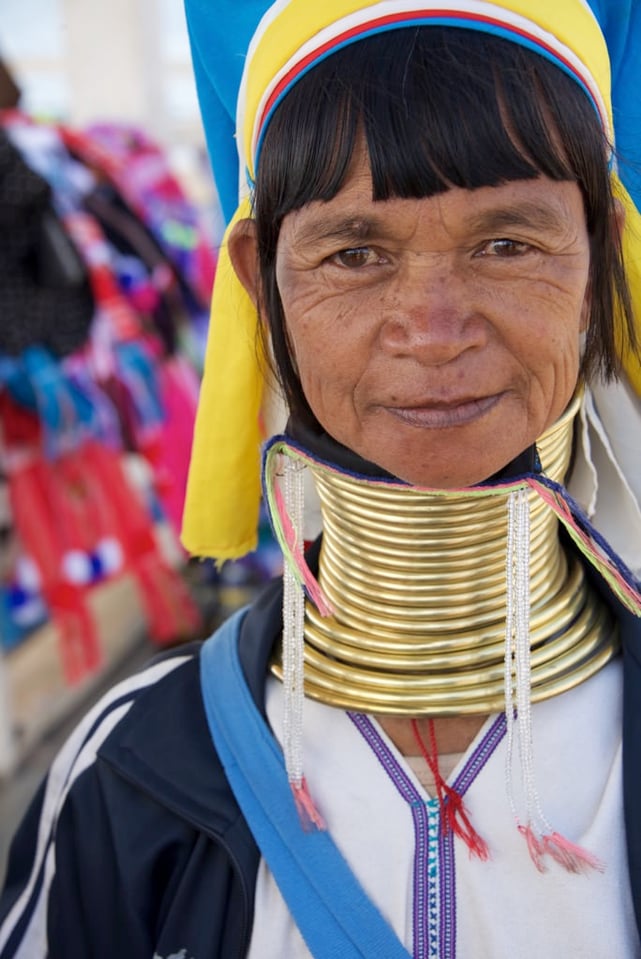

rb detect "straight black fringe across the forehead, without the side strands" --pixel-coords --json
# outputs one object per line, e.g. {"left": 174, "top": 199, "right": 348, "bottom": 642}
{"left": 256, "top": 27, "right": 608, "bottom": 228}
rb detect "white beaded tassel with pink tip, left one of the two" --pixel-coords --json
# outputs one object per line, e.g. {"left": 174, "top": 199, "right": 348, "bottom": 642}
{"left": 283, "top": 457, "right": 325, "bottom": 829}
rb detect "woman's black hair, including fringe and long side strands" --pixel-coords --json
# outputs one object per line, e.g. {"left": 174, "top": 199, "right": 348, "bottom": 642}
{"left": 254, "top": 26, "right": 635, "bottom": 425}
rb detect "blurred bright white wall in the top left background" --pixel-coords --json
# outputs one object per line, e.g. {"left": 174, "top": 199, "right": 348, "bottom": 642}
{"left": 0, "top": 0, "right": 203, "bottom": 145}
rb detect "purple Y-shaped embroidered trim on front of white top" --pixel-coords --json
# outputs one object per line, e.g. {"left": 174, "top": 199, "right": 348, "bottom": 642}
{"left": 347, "top": 713, "right": 505, "bottom": 959}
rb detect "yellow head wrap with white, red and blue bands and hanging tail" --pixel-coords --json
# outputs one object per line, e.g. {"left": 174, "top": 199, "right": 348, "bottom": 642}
{"left": 183, "top": 0, "right": 641, "bottom": 560}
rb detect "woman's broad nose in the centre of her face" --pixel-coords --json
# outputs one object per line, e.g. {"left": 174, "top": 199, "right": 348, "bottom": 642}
{"left": 381, "top": 256, "right": 488, "bottom": 366}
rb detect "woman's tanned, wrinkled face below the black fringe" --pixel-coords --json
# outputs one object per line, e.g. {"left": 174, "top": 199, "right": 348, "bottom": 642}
{"left": 276, "top": 149, "right": 589, "bottom": 488}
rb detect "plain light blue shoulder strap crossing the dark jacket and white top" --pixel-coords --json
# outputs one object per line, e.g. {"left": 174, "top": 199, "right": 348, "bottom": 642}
{"left": 201, "top": 610, "right": 409, "bottom": 959}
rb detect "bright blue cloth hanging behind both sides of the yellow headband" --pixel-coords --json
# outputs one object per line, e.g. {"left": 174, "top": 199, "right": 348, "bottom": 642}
{"left": 185, "top": 0, "right": 641, "bottom": 221}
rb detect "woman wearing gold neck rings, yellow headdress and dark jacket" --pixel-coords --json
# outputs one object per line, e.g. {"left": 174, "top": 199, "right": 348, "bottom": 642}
{"left": 0, "top": 0, "right": 641, "bottom": 959}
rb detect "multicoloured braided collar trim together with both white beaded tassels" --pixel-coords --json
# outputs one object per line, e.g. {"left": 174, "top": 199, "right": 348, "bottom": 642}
{"left": 263, "top": 436, "right": 641, "bottom": 856}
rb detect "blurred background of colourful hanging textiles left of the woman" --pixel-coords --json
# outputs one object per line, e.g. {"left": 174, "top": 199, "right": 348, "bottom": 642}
{"left": 0, "top": 0, "right": 280, "bottom": 878}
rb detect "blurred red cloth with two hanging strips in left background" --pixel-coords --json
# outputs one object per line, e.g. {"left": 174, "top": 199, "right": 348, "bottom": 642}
{"left": 9, "top": 441, "right": 201, "bottom": 683}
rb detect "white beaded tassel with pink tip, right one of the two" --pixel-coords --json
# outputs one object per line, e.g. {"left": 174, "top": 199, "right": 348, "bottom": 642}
{"left": 505, "top": 489, "right": 603, "bottom": 873}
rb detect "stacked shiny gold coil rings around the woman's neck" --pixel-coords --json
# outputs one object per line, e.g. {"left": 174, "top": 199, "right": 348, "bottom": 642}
{"left": 274, "top": 397, "right": 617, "bottom": 716}
